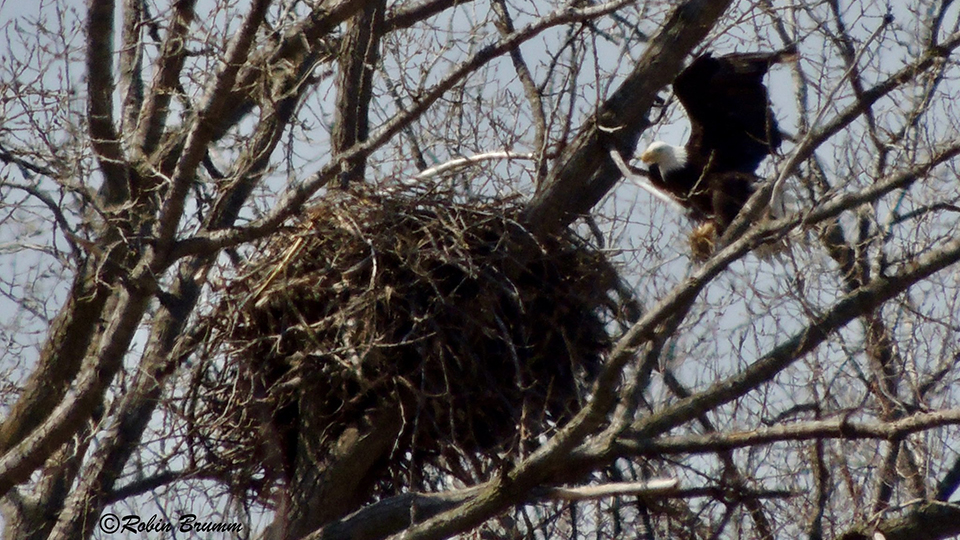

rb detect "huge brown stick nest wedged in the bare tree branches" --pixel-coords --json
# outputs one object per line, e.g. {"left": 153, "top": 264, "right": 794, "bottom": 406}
{"left": 191, "top": 189, "right": 632, "bottom": 498}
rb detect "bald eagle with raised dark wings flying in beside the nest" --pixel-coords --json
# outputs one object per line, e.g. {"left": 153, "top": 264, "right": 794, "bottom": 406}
{"left": 640, "top": 47, "right": 796, "bottom": 256}
